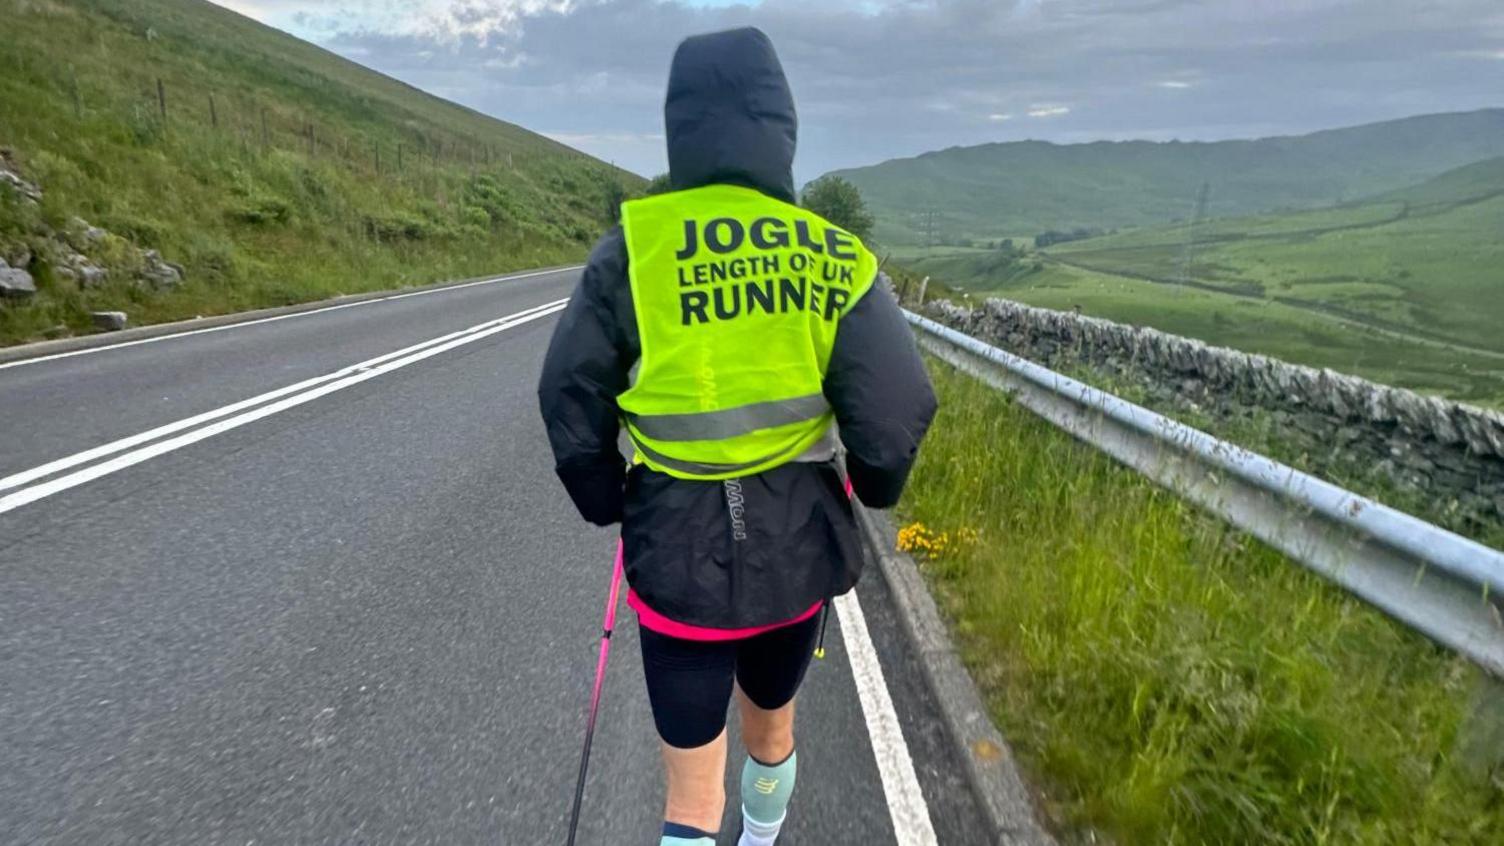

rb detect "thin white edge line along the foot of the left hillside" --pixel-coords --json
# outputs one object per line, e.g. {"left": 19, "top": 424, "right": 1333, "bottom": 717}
{"left": 0, "top": 265, "right": 584, "bottom": 366}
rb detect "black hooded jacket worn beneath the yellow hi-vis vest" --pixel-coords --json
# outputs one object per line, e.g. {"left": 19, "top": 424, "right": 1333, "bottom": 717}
{"left": 538, "top": 29, "right": 935, "bottom": 628}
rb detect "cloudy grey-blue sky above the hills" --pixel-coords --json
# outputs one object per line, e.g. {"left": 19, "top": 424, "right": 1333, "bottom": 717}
{"left": 217, "top": 0, "right": 1504, "bottom": 181}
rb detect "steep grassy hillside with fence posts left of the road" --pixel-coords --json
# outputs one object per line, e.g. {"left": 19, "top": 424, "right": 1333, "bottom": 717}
{"left": 0, "top": 0, "right": 642, "bottom": 343}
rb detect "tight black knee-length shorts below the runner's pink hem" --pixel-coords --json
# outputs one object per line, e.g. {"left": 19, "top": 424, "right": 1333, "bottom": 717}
{"left": 638, "top": 614, "right": 820, "bottom": 750}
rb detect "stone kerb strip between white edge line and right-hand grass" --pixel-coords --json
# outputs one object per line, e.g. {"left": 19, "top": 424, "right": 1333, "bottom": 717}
{"left": 854, "top": 504, "right": 1056, "bottom": 846}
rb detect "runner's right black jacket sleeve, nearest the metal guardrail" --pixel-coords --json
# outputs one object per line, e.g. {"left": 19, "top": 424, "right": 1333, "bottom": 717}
{"left": 824, "top": 274, "right": 935, "bottom": 509}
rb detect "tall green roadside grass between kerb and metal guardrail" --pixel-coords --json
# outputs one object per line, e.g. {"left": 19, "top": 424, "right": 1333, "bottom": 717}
{"left": 901, "top": 358, "right": 1504, "bottom": 843}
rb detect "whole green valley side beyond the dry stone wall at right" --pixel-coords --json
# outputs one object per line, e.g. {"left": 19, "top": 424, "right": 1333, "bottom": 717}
{"left": 908, "top": 158, "right": 1504, "bottom": 406}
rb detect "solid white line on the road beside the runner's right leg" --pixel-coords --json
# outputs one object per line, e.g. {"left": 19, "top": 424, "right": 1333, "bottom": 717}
{"left": 836, "top": 590, "right": 937, "bottom": 846}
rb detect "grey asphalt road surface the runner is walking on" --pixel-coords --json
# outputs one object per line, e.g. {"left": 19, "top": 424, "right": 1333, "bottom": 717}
{"left": 0, "top": 271, "right": 984, "bottom": 846}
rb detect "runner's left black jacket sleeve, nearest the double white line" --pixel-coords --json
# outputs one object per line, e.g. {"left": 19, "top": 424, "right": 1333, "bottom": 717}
{"left": 538, "top": 229, "right": 638, "bottom": 525}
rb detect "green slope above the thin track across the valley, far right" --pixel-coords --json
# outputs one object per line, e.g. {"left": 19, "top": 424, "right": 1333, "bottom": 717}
{"left": 1050, "top": 158, "right": 1504, "bottom": 352}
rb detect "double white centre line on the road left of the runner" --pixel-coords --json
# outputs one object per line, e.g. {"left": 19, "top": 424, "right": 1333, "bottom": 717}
{"left": 0, "top": 300, "right": 566, "bottom": 513}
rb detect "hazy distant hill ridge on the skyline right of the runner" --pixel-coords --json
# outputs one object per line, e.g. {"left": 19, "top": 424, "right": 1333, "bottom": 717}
{"left": 835, "top": 108, "right": 1504, "bottom": 245}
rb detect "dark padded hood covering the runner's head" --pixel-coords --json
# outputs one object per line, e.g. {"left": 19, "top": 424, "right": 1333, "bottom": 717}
{"left": 663, "top": 27, "right": 799, "bottom": 203}
